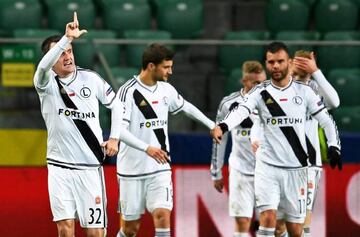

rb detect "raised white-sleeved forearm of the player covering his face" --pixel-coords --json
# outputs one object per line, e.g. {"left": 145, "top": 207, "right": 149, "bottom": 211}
{"left": 312, "top": 70, "right": 340, "bottom": 109}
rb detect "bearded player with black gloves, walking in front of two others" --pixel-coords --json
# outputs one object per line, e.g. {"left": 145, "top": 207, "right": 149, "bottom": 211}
{"left": 211, "top": 42, "right": 341, "bottom": 237}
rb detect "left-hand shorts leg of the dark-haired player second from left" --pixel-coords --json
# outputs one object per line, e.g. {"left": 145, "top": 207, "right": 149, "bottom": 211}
{"left": 118, "top": 179, "right": 147, "bottom": 221}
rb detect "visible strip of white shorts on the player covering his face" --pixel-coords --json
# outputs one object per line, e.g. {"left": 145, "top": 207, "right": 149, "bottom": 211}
{"left": 306, "top": 167, "right": 322, "bottom": 212}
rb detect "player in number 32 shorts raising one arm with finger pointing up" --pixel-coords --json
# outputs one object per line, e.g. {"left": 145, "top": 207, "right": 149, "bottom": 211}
{"left": 34, "top": 13, "right": 117, "bottom": 237}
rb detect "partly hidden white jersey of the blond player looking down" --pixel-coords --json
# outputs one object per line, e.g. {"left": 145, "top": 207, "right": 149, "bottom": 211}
{"left": 210, "top": 89, "right": 256, "bottom": 179}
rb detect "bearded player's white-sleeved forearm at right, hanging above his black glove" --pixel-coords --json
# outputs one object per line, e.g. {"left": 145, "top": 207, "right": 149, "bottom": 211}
{"left": 314, "top": 109, "right": 341, "bottom": 149}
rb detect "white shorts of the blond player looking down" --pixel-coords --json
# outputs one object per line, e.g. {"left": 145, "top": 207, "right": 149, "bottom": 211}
{"left": 229, "top": 168, "right": 255, "bottom": 218}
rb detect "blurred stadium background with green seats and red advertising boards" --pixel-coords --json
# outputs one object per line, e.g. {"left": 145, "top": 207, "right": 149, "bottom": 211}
{"left": 0, "top": 0, "right": 360, "bottom": 237}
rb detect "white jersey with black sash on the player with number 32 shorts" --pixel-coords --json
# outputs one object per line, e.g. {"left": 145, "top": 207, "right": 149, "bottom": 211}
{"left": 34, "top": 68, "right": 116, "bottom": 169}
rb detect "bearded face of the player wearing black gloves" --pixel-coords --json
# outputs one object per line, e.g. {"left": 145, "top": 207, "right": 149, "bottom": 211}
{"left": 266, "top": 50, "right": 290, "bottom": 81}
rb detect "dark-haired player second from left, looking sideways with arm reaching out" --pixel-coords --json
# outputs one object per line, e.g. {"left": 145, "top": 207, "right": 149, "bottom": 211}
{"left": 113, "top": 44, "right": 215, "bottom": 237}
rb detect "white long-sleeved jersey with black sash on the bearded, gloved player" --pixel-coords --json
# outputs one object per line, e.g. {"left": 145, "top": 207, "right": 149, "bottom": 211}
{"left": 223, "top": 79, "right": 340, "bottom": 168}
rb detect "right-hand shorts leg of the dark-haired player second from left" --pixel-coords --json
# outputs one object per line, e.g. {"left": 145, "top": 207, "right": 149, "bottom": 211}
{"left": 146, "top": 172, "right": 173, "bottom": 213}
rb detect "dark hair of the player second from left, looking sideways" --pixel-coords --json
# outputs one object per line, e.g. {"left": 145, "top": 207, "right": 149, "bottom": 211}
{"left": 142, "top": 43, "right": 175, "bottom": 70}
